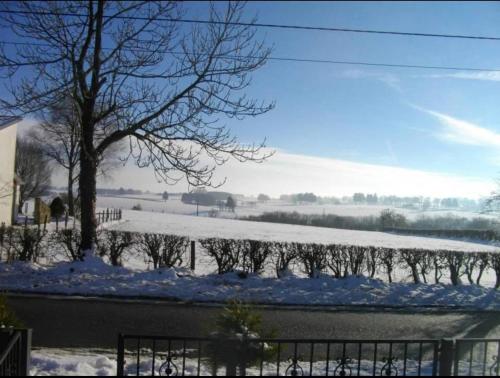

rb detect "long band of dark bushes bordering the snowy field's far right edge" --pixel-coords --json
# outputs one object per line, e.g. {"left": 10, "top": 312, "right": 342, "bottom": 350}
{"left": 240, "top": 209, "right": 500, "bottom": 241}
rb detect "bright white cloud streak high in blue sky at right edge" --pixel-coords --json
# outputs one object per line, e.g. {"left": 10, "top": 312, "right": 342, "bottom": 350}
{"left": 414, "top": 106, "right": 500, "bottom": 147}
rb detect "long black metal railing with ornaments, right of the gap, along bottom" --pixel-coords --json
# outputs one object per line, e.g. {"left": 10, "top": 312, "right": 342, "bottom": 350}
{"left": 117, "top": 335, "right": 500, "bottom": 376}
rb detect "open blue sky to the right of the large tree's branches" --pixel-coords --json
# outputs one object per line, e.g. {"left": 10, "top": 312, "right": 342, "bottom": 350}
{"left": 10, "top": 2, "right": 500, "bottom": 196}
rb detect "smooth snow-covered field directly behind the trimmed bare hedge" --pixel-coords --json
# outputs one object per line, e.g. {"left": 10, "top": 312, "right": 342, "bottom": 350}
{"left": 110, "top": 210, "right": 499, "bottom": 252}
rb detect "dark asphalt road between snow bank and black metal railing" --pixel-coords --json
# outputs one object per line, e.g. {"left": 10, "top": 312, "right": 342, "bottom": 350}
{"left": 9, "top": 295, "right": 500, "bottom": 348}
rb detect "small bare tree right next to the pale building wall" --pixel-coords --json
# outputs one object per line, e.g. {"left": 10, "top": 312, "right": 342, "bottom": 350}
{"left": 16, "top": 137, "right": 52, "bottom": 213}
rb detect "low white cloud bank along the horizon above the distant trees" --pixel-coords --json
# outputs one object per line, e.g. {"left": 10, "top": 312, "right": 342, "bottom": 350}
{"left": 89, "top": 150, "right": 495, "bottom": 198}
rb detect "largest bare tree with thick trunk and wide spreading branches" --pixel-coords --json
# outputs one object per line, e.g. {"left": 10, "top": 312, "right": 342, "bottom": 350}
{"left": 0, "top": 0, "right": 274, "bottom": 254}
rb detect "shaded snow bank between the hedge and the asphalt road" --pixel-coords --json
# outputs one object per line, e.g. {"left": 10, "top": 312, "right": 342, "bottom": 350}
{"left": 0, "top": 259, "right": 500, "bottom": 311}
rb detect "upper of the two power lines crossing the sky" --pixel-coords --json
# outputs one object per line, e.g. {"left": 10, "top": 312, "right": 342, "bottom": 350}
{"left": 0, "top": 10, "right": 500, "bottom": 41}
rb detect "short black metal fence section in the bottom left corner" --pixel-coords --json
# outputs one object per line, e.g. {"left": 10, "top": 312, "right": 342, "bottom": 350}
{"left": 0, "top": 329, "right": 31, "bottom": 377}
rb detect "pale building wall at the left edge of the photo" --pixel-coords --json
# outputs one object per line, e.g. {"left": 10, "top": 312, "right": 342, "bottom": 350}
{"left": 0, "top": 124, "right": 17, "bottom": 225}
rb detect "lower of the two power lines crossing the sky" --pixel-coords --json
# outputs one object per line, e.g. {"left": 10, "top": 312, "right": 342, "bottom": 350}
{"left": 0, "top": 40, "right": 500, "bottom": 72}
